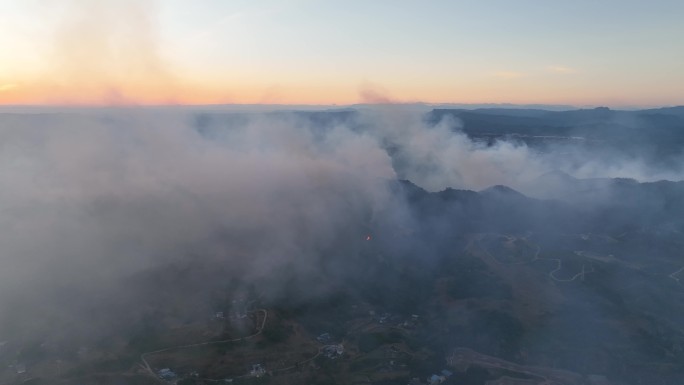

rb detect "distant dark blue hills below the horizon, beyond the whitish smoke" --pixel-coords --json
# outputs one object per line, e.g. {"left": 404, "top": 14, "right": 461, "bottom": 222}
{"left": 426, "top": 106, "right": 684, "bottom": 163}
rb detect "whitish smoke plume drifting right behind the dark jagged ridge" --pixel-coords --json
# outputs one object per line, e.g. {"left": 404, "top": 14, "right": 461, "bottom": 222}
{"left": 356, "top": 107, "right": 682, "bottom": 195}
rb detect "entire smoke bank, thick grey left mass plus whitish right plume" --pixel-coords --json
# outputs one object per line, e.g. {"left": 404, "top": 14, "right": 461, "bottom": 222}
{"left": 0, "top": 109, "right": 680, "bottom": 336}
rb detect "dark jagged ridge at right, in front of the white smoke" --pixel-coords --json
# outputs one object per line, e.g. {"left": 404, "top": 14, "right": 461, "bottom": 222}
{"left": 398, "top": 172, "right": 684, "bottom": 237}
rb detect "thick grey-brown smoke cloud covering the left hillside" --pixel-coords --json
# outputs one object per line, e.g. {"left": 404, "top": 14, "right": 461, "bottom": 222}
{"left": 0, "top": 108, "right": 393, "bottom": 296}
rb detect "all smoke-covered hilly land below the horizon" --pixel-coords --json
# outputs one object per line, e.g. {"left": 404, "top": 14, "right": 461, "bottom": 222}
{"left": 0, "top": 106, "right": 684, "bottom": 385}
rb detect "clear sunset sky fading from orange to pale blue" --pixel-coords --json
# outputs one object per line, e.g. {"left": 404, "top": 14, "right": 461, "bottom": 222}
{"left": 0, "top": 0, "right": 684, "bottom": 107}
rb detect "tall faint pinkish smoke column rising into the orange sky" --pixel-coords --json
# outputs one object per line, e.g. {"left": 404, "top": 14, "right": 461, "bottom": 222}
{"left": 46, "top": 0, "right": 178, "bottom": 105}
